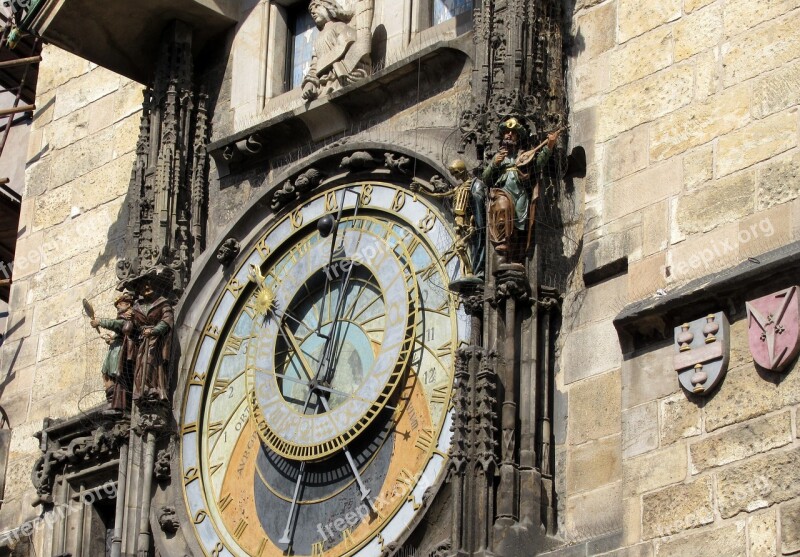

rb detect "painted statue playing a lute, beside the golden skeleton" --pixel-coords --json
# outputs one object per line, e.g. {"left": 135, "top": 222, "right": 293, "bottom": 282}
{"left": 483, "top": 117, "right": 561, "bottom": 261}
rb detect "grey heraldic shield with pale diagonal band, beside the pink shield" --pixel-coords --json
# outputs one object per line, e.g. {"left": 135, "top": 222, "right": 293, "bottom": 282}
{"left": 674, "top": 311, "right": 730, "bottom": 395}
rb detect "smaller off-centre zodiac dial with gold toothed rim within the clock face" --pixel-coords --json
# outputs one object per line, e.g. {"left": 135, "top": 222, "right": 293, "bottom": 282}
{"left": 247, "top": 221, "right": 419, "bottom": 460}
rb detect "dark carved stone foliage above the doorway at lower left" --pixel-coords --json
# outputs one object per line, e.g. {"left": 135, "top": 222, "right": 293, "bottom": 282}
{"left": 31, "top": 422, "right": 128, "bottom": 503}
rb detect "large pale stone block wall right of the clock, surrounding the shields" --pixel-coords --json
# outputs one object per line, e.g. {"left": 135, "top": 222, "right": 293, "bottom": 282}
{"left": 556, "top": 0, "right": 800, "bottom": 556}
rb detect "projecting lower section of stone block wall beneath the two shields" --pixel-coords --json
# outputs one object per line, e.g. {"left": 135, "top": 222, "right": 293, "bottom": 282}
{"left": 622, "top": 316, "right": 800, "bottom": 557}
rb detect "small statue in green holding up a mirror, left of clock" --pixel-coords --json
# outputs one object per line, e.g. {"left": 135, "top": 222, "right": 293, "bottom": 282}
{"left": 89, "top": 292, "right": 135, "bottom": 414}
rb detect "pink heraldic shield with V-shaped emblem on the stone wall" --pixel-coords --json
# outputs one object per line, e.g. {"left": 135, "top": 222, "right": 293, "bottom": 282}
{"left": 746, "top": 286, "right": 800, "bottom": 371}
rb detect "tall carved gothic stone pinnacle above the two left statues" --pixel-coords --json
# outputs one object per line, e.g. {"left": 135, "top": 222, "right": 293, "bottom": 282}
{"left": 117, "top": 22, "right": 208, "bottom": 291}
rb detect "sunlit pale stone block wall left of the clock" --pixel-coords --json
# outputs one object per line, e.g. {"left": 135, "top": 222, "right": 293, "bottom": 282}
{"left": 0, "top": 47, "right": 142, "bottom": 530}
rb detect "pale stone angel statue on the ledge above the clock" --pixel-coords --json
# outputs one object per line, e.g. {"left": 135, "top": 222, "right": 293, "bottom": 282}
{"left": 303, "top": 0, "right": 375, "bottom": 101}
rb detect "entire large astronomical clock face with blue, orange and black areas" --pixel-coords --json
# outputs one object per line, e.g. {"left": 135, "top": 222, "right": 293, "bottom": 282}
{"left": 181, "top": 182, "right": 469, "bottom": 557}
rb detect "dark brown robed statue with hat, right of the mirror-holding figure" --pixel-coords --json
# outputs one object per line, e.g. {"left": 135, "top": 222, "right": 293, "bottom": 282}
{"left": 121, "top": 265, "right": 175, "bottom": 402}
